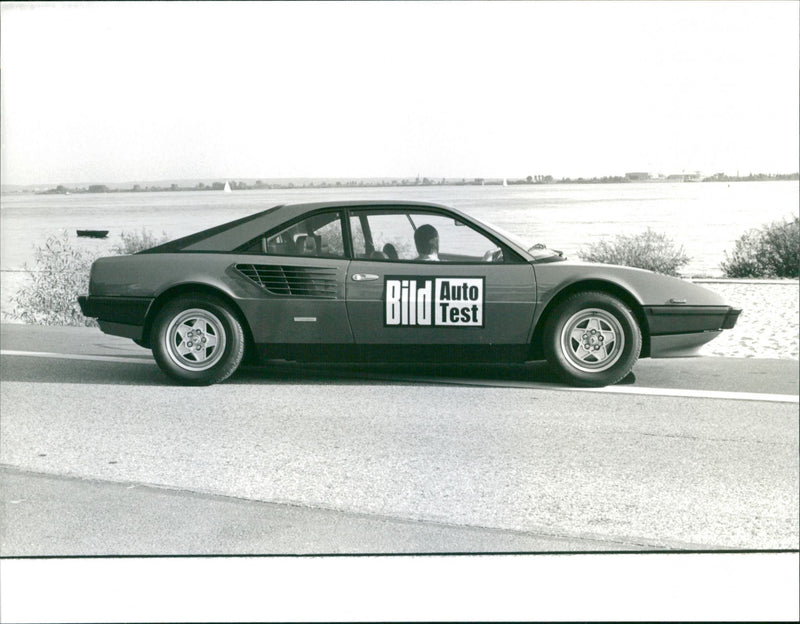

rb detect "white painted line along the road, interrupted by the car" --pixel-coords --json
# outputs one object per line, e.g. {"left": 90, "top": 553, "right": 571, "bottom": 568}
{"left": 0, "top": 349, "right": 800, "bottom": 403}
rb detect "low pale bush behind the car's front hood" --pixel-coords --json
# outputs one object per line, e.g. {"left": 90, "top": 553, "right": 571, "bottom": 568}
{"left": 578, "top": 228, "right": 689, "bottom": 276}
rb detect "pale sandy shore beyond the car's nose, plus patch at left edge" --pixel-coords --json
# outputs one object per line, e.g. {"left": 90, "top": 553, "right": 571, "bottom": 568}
{"left": 0, "top": 271, "right": 800, "bottom": 360}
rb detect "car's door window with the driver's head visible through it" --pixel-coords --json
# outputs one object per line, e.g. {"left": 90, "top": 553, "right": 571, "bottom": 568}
{"left": 350, "top": 211, "right": 503, "bottom": 263}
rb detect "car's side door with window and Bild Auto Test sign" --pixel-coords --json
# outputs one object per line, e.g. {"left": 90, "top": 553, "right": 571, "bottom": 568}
{"left": 345, "top": 207, "right": 535, "bottom": 348}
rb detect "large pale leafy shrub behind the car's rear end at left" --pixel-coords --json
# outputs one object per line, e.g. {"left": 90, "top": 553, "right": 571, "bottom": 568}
{"left": 6, "top": 231, "right": 97, "bottom": 326}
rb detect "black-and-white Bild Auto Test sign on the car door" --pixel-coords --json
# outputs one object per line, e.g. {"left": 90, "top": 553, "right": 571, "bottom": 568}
{"left": 384, "top": 276, "right": 485, "bottom": 327}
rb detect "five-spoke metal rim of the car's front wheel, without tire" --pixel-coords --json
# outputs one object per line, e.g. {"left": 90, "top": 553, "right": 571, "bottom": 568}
{"left": 561, "top": 308, "right": 625, "bottom": 373}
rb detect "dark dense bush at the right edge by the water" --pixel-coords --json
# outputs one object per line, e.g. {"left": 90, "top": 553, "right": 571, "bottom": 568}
{"left": 719, "top": 217, "right": 800, "bottom": 278}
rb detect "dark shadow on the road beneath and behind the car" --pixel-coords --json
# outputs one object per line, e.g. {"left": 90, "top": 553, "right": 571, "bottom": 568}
{"left": 1, "top": 356, "right": 632, "bottom": 386}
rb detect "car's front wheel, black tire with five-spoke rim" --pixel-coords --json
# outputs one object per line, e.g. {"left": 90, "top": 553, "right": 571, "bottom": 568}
{"left": 544, "top": 291, "right": 642, "bottom": 387}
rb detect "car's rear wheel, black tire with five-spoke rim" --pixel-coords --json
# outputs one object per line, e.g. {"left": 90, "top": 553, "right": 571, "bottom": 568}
{"left": 150, "top": 296, "right": 245, "bottom": 386}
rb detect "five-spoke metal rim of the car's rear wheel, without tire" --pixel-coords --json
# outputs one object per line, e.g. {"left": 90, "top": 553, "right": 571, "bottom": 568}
{"left": 166, "top": 308, "right": 226, "bottom": 371}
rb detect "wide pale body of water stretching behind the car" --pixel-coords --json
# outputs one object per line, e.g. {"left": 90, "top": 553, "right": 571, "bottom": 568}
{"left": 0, "top": 181, "right": 800, "bottom": 276}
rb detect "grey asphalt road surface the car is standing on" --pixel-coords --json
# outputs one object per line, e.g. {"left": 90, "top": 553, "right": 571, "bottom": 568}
{"left": 0, "top": 325, "right": 799, "bottom": 556}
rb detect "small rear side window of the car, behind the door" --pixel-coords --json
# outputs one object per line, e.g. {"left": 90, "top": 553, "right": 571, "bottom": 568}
{"left": 264, "top": 212, "right": 344, "bottom": 258}
